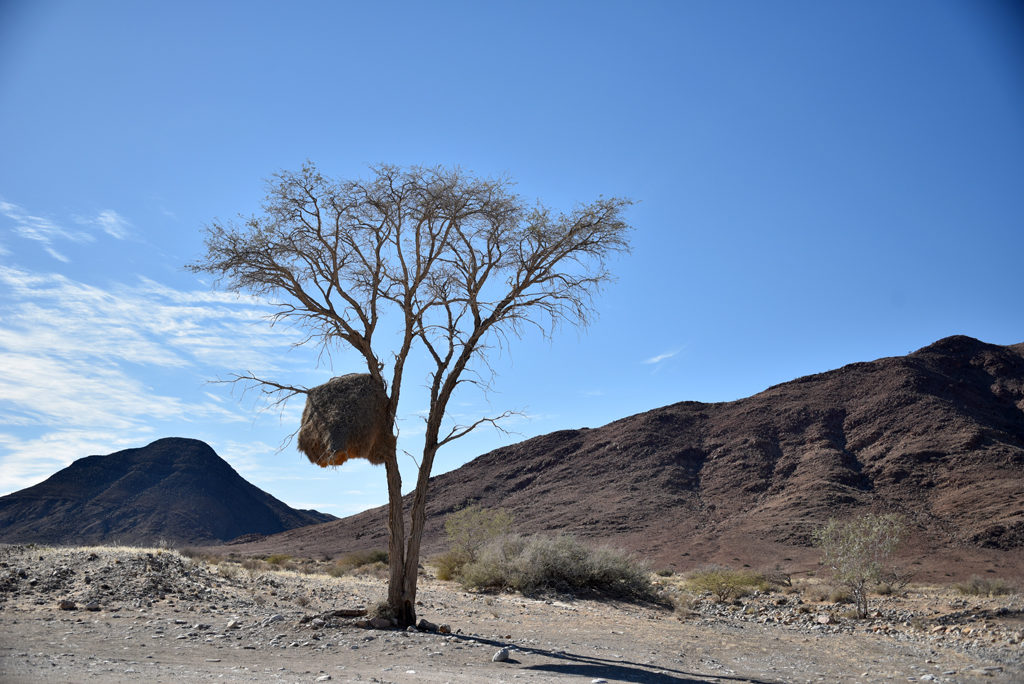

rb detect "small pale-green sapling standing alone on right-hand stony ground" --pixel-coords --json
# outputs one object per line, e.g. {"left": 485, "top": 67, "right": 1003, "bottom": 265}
{"left": 814, "top": 513, "right": 907, "bottom": 617}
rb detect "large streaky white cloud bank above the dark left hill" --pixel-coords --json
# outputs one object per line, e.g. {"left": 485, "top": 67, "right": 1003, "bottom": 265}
{"left": 0, "top": 266, "right": 308, "bottom": 494}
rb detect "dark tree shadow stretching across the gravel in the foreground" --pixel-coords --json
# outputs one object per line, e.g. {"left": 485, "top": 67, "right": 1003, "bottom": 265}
{"left": 453, "top": 634, "right": 771, "bottom": 684}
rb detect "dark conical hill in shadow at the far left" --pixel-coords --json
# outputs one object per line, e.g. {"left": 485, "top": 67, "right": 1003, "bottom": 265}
{"left": 0, "top": 437, "right": 335, "bottom": 545}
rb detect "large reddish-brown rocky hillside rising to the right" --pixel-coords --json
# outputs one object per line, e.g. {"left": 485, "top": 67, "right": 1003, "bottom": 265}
{"left": 216, "top": 336, "right": 1024, "bottom": 568}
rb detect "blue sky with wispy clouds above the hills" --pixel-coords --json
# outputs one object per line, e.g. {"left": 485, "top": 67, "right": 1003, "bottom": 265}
{"left": 0, "top": 0, "right": 1024, "bottom": 515}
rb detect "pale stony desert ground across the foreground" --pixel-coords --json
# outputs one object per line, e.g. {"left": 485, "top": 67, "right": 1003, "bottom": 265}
{"left": 0, "top": 546, "right": 1024, "bottom": 684}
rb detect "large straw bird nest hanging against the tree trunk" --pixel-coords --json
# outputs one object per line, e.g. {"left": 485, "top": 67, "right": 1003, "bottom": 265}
{"left": 299, "top": 373, "right": 395, "bottom": 468}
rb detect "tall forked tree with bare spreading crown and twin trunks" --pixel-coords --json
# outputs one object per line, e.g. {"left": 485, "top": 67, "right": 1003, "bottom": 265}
{"left": 189, "top": 163, "right": 630, "bottom": 625}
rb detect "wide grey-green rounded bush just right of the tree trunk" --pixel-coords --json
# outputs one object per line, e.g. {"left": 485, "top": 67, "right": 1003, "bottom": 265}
{"left": 461, "top": 535, "right": 655, "bottom": 600}
